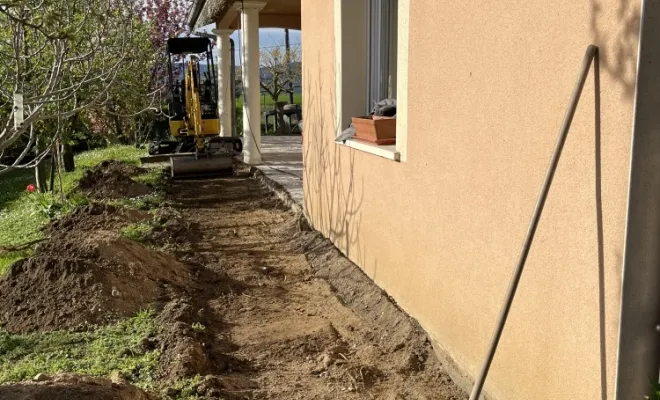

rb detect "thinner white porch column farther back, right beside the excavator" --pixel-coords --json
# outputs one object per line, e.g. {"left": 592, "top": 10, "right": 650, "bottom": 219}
{"left": 213, "top": 29, "right": 234, "bottom": 137}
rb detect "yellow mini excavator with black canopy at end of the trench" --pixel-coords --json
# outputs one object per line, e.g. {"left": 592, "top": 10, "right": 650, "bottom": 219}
{"left": 149, "top": 37, "right": 243, "bottom": 178}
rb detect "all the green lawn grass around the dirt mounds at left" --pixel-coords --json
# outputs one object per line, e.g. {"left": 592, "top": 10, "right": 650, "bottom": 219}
{"left": 0, "top": 146, "right": 201, "bottom": 400}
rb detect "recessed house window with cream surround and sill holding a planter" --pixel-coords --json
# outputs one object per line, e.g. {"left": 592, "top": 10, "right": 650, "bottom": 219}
{"left": 334, "top": 0, "right": 410, "bottom": 161}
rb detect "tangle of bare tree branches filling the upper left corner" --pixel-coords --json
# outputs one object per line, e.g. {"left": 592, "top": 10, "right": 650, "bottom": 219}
{"left": 0, "top": 0, "right": 143, "bottom": 174}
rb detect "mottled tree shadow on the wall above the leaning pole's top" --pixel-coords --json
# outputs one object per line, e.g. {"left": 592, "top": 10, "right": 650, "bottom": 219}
{"left": 589, "top": 0, "right": 640, "bottom": 99}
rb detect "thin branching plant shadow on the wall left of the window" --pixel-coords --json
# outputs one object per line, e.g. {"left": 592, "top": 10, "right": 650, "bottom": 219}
{"left": 303, "top": 53, "right": 365, "bottom": 266}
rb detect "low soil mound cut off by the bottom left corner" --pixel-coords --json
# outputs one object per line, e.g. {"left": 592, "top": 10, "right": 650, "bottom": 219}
{"left": 0, "top": 374, "right": 156, "bottom": 400}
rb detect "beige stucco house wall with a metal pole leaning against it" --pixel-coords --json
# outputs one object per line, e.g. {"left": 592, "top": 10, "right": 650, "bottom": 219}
{"left": 302, "top": 0, "right": 640, "bottom": 400}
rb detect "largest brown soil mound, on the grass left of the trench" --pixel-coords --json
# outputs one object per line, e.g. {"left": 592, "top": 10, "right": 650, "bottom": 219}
{"left": 0, "top": 205, "right": 191, "bottom": 333}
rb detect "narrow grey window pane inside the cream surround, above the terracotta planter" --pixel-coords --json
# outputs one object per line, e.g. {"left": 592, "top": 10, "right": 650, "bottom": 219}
{"left": 366, "top": 0, "right": 398, "bottom": 112}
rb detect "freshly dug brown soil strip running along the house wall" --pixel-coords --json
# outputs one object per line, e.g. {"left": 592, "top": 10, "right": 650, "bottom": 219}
{"left": 158, "top": 176, "right": 467, "bottom": 400}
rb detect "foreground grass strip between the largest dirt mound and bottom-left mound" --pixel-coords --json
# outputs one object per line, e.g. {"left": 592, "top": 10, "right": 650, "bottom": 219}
{"left": 0, "top": 311, "right": 160, "bottom": 389}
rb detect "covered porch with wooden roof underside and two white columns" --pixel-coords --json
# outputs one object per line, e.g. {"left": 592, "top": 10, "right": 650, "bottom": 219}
{"left": 188, "top": 0, "right": 300, "bottom": 165}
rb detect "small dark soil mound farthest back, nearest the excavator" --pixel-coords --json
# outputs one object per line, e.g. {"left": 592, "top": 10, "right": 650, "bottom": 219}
{"left": 78, "top": 161, "right": 151, "bottom": 199}
